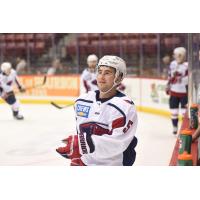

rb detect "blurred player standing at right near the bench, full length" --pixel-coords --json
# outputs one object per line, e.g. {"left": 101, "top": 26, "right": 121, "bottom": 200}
{"left": 166, "top": 47, "right": 188, "bottom": 134}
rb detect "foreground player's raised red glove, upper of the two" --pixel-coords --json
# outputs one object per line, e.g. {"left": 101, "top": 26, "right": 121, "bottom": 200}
{"left": 56, "top": 135, "right": 81, "bottom": 159}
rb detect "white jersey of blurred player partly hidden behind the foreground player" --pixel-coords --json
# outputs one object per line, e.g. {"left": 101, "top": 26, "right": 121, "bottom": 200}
{"left": 81, "top": 69, "right": 98, "bottom": 92}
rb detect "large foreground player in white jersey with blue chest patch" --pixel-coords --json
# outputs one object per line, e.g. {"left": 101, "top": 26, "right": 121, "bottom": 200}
{"left": 57, "top": 56, "right": 138, "bottom": 166}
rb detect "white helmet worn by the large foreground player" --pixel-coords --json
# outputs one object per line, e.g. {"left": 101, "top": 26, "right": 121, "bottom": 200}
{"left": 97, "top": 55, "right": 126, "bottom": 80}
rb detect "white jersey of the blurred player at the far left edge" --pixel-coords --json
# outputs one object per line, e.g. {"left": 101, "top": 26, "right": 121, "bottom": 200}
{"left": 0, "top": 69, "right": 21, "bottom": 94}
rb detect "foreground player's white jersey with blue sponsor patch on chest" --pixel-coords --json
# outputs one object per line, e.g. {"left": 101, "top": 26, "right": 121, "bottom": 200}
{"left": 75, "top": 91, "right": 138, "bottom": 166}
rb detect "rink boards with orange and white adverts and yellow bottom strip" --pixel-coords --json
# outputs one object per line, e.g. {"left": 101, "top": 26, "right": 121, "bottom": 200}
{"left": 0, "top": 75, "right": 170, "bottom": 117}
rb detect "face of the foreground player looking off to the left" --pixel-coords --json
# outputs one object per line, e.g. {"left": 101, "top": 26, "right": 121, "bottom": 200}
{"left": 97, "top": 66, "right": 115, "bottom": 92}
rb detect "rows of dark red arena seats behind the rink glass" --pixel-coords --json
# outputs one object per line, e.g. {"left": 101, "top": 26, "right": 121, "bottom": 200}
{"left": 0, "top": 33, "right": 186, "bottom": 72}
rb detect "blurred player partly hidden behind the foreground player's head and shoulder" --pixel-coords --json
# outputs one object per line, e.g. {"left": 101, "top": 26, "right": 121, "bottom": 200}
{"left": 81, "top": 54, "right": 98, "bottom": 92}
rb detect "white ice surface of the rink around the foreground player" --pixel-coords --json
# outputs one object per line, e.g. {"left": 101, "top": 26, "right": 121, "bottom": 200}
{"left": 0, "top": 104, "right": 176, "bottom": 166}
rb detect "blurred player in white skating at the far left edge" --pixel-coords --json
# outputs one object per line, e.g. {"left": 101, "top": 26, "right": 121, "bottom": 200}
{"left": 0, "top": 62, "right": 25, "bottom": 120}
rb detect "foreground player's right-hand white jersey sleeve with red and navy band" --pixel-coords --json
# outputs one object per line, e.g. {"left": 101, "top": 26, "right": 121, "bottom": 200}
{"left": 81, "top": 102, "right": 138, "bottom": 164}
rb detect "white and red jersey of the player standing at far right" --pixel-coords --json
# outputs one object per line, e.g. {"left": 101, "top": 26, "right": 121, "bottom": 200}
{"left": 168, "top": 60, "right": 188, "bottom": 96}
